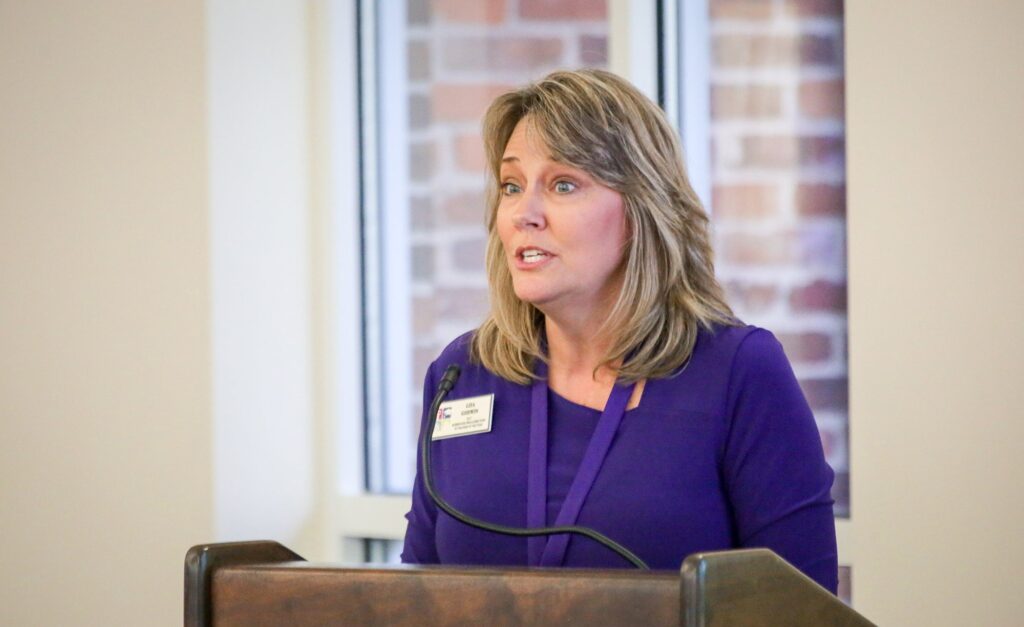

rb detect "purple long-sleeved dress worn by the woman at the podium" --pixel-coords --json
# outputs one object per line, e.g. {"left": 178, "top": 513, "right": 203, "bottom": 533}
{"left": 401, "top": 327, "right": 838, "bottom": 593}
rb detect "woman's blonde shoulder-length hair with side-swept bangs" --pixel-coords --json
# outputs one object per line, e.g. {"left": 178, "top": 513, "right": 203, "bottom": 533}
{"left": 470, "top": 70, "right": 736, "bottom": 384}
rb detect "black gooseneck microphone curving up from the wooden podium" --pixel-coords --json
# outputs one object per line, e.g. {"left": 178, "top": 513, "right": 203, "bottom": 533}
{"left": 420, "top": 364, "right": 650, "bottom": 571}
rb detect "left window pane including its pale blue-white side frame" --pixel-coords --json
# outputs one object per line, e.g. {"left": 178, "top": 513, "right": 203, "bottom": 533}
{"left": 364, "top": 0, "right": 608, "bottom": 492}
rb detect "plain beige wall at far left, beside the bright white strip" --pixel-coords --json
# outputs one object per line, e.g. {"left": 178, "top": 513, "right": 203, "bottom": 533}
{"left": 0, "top": 0, "right": 213, "bottom": 625}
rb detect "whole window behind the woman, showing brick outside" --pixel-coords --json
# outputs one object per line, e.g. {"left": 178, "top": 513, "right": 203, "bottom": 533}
{"left": 340, "top": 0, "right": 849, "bottom": 594}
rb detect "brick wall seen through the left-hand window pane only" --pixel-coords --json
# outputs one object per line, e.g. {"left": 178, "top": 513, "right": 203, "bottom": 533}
{"left": 399, "top": 0, "right": 608, "bottom": 477}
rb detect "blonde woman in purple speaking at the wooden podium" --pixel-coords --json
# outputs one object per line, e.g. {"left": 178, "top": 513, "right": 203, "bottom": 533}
{"left": 402, "top": 71, "right": 837, "bottom": 592}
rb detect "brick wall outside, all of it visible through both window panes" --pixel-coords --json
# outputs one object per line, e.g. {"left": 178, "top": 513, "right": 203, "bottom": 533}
{"left": 390, "top": 0, "right": 849, "bottom": 513}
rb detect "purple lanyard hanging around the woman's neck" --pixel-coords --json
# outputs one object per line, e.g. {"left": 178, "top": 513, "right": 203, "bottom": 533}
{"left": 526, "top": 364, "right": 634, "bottom": 567}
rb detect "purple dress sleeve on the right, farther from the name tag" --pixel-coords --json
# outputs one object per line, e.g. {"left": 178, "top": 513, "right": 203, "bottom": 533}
{"left": 723, "top": 330, "right": 838, "bottom": 593}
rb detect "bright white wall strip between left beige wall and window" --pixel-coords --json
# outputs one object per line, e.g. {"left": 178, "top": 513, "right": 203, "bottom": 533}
{"left": 206, "top": 0, "right": 326, "bottom": 559}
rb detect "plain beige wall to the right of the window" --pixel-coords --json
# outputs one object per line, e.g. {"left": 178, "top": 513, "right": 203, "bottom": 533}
{"left": 846, "top": 0, "right": 1024, "bottom": 625}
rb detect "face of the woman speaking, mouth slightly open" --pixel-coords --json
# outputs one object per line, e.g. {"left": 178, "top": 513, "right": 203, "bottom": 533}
{"left": 496, "top": 120, "right": 628, "bottom": 318}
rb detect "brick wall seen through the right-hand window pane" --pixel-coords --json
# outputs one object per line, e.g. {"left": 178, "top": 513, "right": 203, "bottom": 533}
{"left": 710, "top": 0, "right": 849, "bottom": 514}
